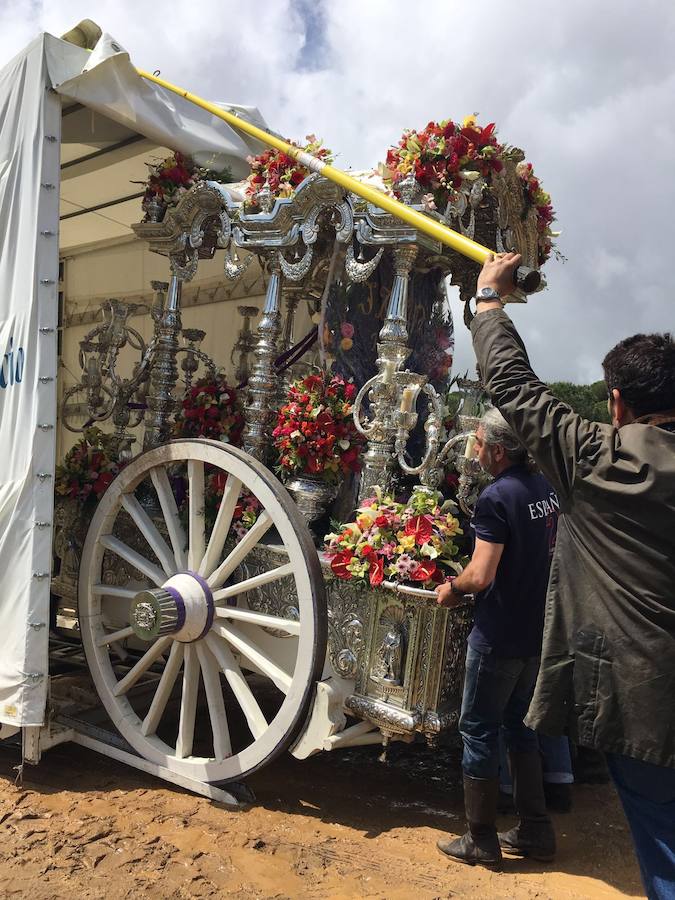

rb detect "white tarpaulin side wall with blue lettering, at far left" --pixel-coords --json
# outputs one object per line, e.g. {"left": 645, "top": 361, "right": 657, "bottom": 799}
{"left": 0, "top": 38, "right": 61, "bottom": 725}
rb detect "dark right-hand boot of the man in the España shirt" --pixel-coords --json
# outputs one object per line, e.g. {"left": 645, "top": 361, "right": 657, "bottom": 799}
{"left": 499, "top": 750, "right": 556, "bottom": 862}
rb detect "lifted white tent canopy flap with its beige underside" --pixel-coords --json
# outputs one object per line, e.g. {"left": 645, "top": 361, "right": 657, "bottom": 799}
{"left": 51, "top": 35, "right": 266, "bottom": 251}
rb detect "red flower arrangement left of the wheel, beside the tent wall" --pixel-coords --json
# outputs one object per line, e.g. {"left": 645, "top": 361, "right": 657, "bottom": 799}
{"left": 54, "top": 428, "right": 124, "bottom": 505}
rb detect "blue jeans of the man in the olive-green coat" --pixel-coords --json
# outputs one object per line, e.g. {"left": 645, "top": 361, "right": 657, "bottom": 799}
{"left": 607, "top": 753, "right": 675, "bottom": 900}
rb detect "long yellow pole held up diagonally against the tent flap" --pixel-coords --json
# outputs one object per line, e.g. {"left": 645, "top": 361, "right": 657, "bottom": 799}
{"left": 136, "top": 69, "right": 493, "bottom": 264}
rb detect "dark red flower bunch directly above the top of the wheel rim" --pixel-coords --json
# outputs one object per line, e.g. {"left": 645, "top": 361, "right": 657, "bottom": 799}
{"left": 174, "top": 375, "right": 244, "bottom": 446}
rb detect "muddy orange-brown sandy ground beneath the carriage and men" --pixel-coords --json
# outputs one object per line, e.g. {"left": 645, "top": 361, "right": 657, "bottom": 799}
{"left": 0, "top": 732, "right": 644, "bottom": 900}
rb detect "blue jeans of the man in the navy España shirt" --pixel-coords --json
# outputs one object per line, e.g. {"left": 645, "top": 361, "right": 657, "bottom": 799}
{"left": 459, "top": 647, "right": 539, "bottom": 778}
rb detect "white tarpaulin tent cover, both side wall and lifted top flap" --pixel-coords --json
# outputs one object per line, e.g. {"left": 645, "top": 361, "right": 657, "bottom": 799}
{"left": 0, "top": 29, "right": 264, "bottom": 725}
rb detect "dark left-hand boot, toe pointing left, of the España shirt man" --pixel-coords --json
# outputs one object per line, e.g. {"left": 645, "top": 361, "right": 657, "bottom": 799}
{"left": 437, "top": 773, "right": 502, "bottom": 871}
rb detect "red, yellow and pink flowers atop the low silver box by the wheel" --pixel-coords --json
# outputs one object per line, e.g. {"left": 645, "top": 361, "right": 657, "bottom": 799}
{"left": 325, "top": 488, "right": 465, "bottom": 588}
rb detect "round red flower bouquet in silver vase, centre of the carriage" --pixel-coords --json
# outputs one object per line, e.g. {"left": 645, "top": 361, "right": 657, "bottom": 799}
{"left": 272, "top": 372, "right": 363, "bottom": 481}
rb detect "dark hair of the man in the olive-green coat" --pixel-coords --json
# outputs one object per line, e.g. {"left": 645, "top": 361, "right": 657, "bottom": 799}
{"left": 602, "top": 332, "right": 675, "bottom": 417}
